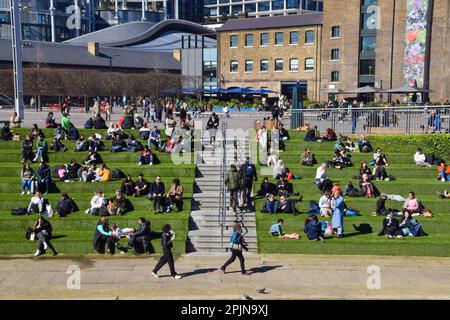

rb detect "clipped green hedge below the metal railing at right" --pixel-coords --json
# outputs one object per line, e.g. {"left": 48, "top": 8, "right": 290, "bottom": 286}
{"left": 367, "top": 134, "right": 450, "bottom": 161}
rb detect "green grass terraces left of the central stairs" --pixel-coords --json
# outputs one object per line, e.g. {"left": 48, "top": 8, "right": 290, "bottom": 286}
{"left": 0, "top": 129, "right": 195, "bottom": 256}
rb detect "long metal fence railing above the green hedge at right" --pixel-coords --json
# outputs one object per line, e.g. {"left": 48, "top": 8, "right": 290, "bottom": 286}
{"left": 291, "top": 105, "right": 450, "bottom": 134}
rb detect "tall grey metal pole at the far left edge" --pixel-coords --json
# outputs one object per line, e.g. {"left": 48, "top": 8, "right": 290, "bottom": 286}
{"left": 9, "top": 0, "right": 25, "bottom": 120}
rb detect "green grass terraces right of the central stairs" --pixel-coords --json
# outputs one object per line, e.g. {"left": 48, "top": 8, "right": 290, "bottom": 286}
{"left": 254, "top": 131, "right": 450, "bottom": 257}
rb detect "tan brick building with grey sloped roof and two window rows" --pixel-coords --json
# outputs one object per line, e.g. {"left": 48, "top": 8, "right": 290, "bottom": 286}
{"left": 217, "top": 13, "right": 322, "bottom": 100}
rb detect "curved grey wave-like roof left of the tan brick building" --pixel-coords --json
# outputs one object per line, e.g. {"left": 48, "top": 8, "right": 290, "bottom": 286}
{"left": 65, "top": 19, "right": 216, "bottom": 51}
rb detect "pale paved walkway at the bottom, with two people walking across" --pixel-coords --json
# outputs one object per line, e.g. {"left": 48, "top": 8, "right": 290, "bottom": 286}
{"left": 0, "top": 253, "right": 450, "bottom": 300}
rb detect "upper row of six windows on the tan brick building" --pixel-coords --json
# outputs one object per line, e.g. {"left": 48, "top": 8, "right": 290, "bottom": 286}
{"left": 230, "top": 31, "right": 314, "bottom": 48}
